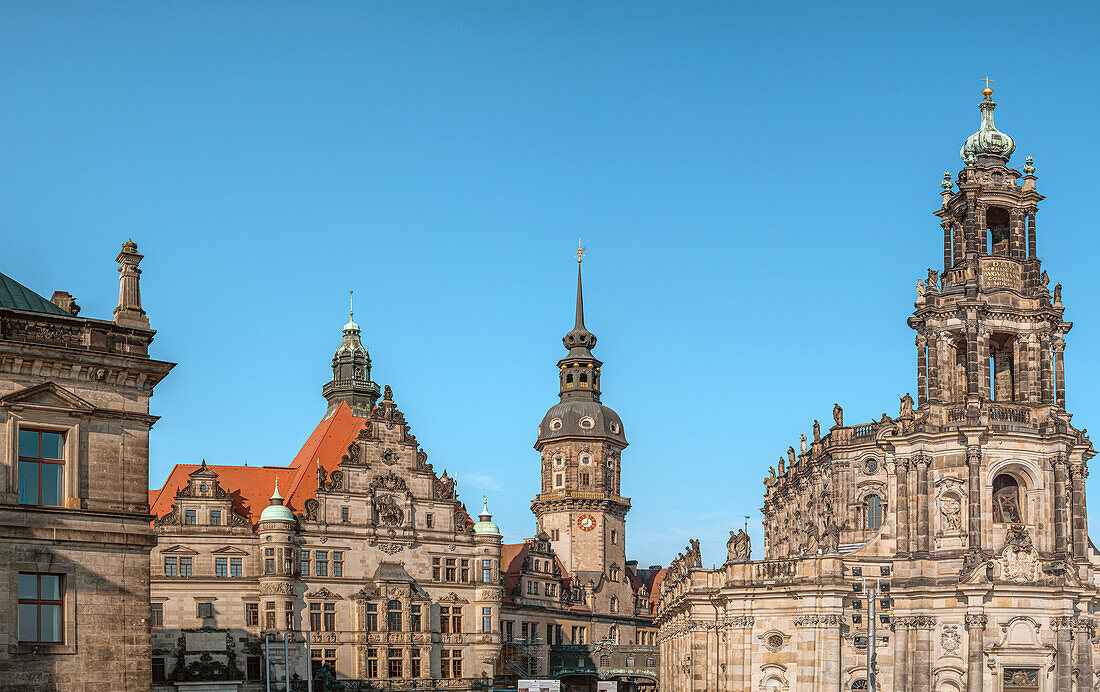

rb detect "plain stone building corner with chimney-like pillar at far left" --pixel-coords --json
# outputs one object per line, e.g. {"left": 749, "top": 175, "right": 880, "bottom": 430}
{"left": 0, "top": 242, "right": 173, "bottom": 692}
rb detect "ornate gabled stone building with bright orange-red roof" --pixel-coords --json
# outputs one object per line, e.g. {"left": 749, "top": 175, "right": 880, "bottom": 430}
{"left": 152, "top": 314, "right": 501, "bottom": 692}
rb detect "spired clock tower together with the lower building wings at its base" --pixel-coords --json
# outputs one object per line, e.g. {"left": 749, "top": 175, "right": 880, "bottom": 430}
{"left": 495, "top": 264, "right": 661, "bottom": 692}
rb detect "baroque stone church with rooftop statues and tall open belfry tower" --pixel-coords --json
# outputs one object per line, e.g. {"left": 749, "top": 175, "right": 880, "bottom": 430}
{"left": 658, "top": 90, "right": 1100, "bottom": 692}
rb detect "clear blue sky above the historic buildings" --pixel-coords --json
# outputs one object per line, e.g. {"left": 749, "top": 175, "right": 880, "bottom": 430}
{"left": 0, "top": 1, "right": 1100, "bottom": 564}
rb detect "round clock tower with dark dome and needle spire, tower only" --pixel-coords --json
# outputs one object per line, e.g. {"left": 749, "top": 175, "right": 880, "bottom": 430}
{"left": 531, "top": 249, "right": 630, "bottom": 584}
